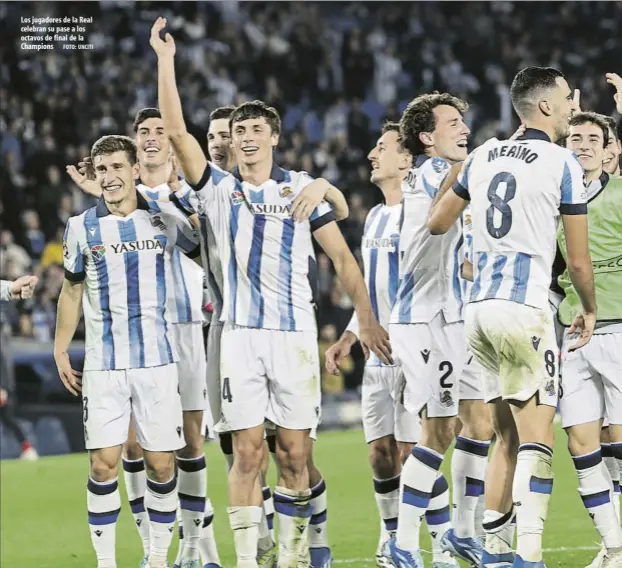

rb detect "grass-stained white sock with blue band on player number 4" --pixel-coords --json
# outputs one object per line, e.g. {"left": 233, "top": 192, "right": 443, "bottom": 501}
{"left": 273, "top": 487, "right": 312, "bottom": 568}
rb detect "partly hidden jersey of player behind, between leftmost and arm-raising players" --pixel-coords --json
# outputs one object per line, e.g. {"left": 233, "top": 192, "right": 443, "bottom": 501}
{"left": 136, "top": 180, "right": 203, "bottom": 323}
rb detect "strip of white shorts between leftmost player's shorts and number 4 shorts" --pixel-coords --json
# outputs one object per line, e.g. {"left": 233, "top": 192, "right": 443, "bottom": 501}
{"left": 172, "top": 322, "right": 209, "bottom": 412}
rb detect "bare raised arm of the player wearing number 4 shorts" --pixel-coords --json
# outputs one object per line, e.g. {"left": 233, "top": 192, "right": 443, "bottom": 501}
{"left": 149, "top": 18, "right": 208, "bottom": 185}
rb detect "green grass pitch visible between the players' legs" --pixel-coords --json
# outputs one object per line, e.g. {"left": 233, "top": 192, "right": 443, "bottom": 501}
{"left": 0, "top": 430, "right": 598, "bottom": 568}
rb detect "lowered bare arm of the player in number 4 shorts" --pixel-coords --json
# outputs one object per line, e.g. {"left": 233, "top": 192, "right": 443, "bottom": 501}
{"left": 313, "top": 223, "right": 393, "bottom": 365}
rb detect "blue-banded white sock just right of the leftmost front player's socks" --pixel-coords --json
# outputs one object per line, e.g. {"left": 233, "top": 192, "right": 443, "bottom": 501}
{"left": 177, "top": 456, "right": 207, "bottom": 560}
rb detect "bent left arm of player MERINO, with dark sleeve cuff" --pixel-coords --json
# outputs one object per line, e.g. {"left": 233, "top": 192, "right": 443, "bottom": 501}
{"left": 428, "top": 159, "right": 470, "bottom": 235}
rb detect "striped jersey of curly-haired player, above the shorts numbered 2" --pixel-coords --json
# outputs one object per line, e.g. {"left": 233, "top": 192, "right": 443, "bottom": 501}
{"left": 391, "top": 156, "right": 463, "bottom": 324}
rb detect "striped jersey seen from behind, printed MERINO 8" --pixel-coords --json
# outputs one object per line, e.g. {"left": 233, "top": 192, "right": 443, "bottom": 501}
{"left": 454, "top": 128, "right": 587, "bottom": 309}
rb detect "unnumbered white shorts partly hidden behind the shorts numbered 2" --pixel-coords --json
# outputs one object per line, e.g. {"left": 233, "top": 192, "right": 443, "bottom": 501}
{"left": 361, "top": 367, "right": 421, "bottom": 444}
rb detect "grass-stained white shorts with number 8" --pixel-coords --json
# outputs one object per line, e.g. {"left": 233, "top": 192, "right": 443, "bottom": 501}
{"left": 465, "top": 300, "right": 559, "bottom": 407}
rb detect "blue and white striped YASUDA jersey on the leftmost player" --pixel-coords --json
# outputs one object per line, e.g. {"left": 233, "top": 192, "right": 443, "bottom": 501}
{"left": 63, "top": 193, "right": 198, "bottom": 371}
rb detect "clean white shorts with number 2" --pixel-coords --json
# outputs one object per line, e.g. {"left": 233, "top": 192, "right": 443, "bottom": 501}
{"left": 389, "top": 313, "right": 466, "bottom": 418}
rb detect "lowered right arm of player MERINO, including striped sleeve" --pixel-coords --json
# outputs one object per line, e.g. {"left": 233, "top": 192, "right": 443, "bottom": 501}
{"left": 559, "top": 157, "right": 596, "bottom": 351}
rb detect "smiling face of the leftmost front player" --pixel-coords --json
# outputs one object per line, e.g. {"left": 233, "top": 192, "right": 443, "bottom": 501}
{"left": 93, "top": 150, "right": 140, "bottom": 205}
